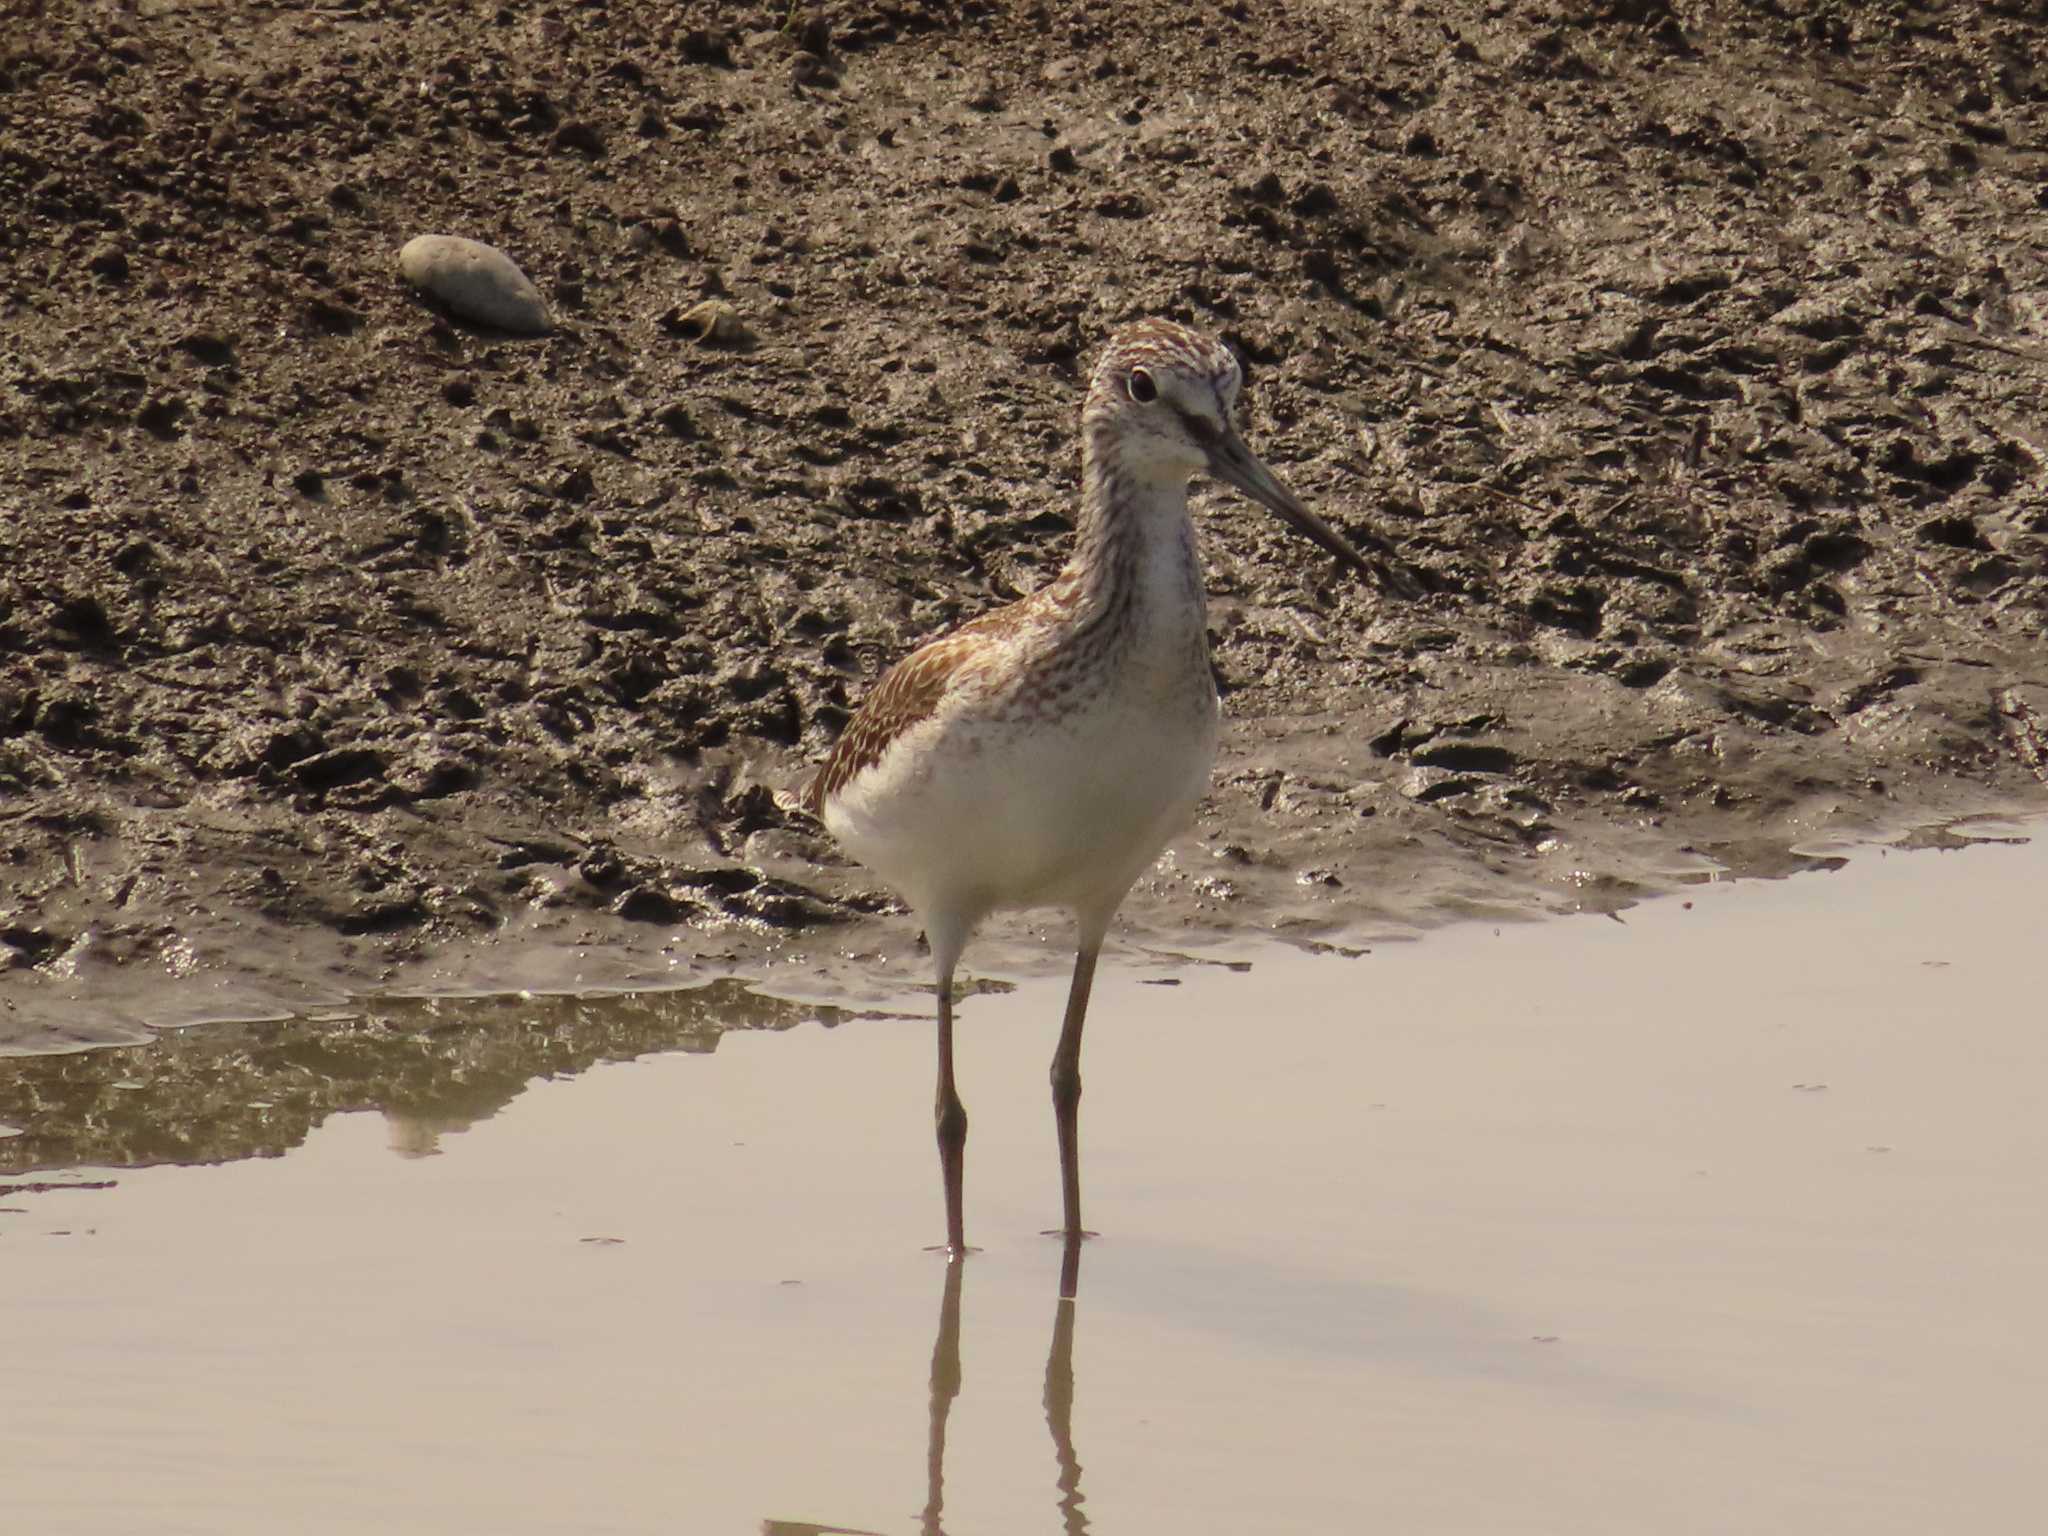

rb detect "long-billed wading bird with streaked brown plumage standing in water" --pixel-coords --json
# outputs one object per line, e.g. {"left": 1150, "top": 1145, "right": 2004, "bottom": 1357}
{"left": 801, "top": 319, "right": 1384, "bottom": 1255}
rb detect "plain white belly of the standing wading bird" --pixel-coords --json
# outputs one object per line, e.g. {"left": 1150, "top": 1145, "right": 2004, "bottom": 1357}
{"left": 825, "top": 666, "right": 1219, "bottom": 913}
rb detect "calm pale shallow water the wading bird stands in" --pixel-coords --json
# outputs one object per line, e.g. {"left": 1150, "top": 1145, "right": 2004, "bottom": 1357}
{"left": 0, "top": 840, "right": 2048, "bottom": 1536}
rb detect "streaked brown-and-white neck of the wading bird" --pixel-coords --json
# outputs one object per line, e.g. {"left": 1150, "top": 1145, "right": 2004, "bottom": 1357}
{"left": 1063, "top": 432, "right": 1204, "bottom": 625}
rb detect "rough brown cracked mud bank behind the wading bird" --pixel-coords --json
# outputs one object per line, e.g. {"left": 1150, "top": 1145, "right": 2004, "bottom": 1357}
{"left": 0, "top": 0, "right": 2048, "bottom": 1049}
